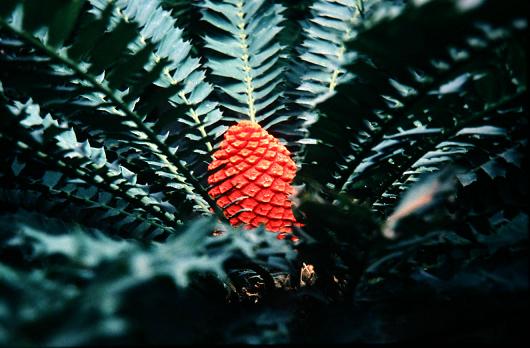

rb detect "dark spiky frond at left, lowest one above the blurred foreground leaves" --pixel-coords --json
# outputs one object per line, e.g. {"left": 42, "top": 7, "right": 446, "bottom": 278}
{"left": 0, "top": 100, "right": 180, "bottom": 238}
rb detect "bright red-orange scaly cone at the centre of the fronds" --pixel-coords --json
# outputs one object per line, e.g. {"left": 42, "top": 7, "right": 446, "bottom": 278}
{"left": 208, "top": 121, "right": 300, "bottom": 238}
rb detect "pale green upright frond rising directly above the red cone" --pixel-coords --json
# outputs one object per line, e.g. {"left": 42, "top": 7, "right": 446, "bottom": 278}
{"left": 201, "top": 0, "right": 284, "bottom": 127}
